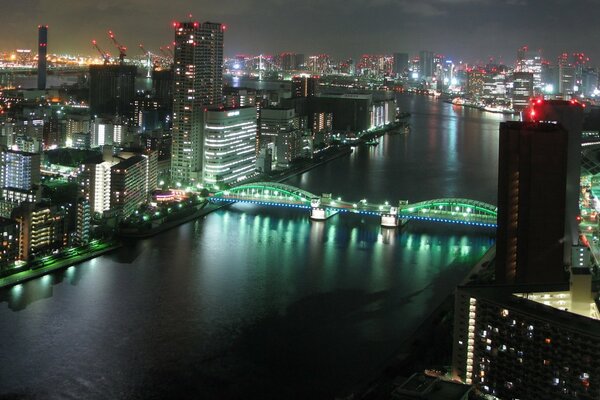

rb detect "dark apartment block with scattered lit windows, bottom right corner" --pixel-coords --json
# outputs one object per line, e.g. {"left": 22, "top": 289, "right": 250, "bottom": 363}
{"left": 452, "top": 268, "right": 600, "bottom": 399}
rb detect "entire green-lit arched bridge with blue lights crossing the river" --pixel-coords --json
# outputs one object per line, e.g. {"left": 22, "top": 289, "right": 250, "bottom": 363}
{"left": 210, "top": 182, "right": 497, "bottom": 228}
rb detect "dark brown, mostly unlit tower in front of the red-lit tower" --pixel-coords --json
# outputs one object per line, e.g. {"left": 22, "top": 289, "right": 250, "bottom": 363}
{"left": 496, "top": 122, "right": 568, "bottom": 283}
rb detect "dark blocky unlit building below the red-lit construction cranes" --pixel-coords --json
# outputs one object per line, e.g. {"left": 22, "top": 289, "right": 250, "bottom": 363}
{"left": 90, "top": 64, "right": 137, "bottom": 123}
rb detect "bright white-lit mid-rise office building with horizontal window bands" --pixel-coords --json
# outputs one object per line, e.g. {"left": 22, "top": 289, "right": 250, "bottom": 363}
{"left": 203, "top": 107, "right": 256, "bottom": 185}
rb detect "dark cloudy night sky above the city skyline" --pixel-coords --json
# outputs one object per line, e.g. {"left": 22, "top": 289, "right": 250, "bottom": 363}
{"left": 0, "top": 0, "right": 600, "bottom": 65}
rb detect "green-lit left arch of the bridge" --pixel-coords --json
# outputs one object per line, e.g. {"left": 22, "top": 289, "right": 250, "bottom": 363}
{"left": 211, "top": 182, "right": 319, "bottom": 204}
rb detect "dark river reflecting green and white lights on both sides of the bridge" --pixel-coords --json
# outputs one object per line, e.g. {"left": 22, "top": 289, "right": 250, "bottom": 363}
{"left": 0, "top": 96, "right": 510, "bottom": 399}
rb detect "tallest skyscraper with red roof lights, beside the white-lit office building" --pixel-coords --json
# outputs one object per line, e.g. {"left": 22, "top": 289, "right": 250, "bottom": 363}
{"left": 171, "top": 22, "right": 224, "bottom": 184}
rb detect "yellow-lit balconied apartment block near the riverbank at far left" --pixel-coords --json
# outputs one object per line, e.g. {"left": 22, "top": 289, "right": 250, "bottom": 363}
{"left": 12, "top": 202, "right": 68, "bottom": 260}
